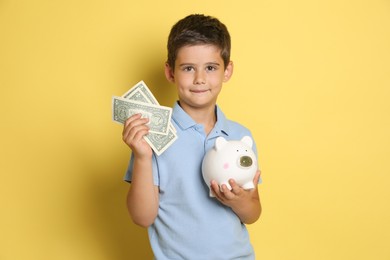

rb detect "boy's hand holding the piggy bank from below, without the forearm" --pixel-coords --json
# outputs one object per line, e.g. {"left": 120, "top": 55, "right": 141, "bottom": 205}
{"left": 211, "top": 171, "right": 260, "bottom": 210}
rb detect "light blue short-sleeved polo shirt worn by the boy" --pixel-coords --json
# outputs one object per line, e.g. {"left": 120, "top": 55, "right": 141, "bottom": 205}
{"left": 125, "top": 103, "right": 257, "bottom": 260}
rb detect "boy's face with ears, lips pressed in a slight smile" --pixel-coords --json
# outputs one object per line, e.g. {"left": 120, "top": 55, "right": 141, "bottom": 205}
{"left": 165, "top": 45, "right": 233, "bottom": 110}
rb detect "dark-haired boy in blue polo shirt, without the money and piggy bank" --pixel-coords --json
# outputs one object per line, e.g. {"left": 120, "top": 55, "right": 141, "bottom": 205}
{"left": 123, "top": 15, "right": 261, "bottom": 260}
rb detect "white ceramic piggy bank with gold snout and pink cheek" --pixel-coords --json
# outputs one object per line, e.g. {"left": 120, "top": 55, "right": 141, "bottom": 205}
{"left": 202, "top": 136, "right": 257, "bottom": 197}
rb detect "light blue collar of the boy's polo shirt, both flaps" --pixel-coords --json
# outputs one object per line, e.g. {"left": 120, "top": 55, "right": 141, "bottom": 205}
{"left": 172, "top": 102, "right": 229, "bottom": 135}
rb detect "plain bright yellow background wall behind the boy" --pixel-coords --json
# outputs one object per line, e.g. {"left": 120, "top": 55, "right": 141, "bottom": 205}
{"left": 0, "top": 0, "right": 390, "bottom": 260}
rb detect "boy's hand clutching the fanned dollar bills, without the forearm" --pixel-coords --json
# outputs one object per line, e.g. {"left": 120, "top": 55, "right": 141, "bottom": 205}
{"left": 122, "top": 114, "right": 152, "bottom": 158}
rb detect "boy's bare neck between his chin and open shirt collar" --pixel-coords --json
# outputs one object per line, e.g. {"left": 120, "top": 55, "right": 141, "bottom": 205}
{"left": 179, "top": 102, "right": 217, "bottom": 135}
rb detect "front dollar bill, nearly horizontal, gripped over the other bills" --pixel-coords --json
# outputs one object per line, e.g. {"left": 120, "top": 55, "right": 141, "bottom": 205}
{"left": 112, "top": 96, "right": 172, "bottom": 135}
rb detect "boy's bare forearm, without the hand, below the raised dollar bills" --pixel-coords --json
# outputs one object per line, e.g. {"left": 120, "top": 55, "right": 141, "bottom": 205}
{"left": 127, "top": 158, "right": 159, "bottom": 227}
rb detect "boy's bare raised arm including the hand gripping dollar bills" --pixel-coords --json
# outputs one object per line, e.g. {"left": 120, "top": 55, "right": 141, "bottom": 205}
{"left": 122, "top": 114, "right": 159, "bottom": 227}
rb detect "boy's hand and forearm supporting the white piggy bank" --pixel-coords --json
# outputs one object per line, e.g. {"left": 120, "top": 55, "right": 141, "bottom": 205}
{"left": 211, "top": 171, "right": 261, "bottom": 224}
